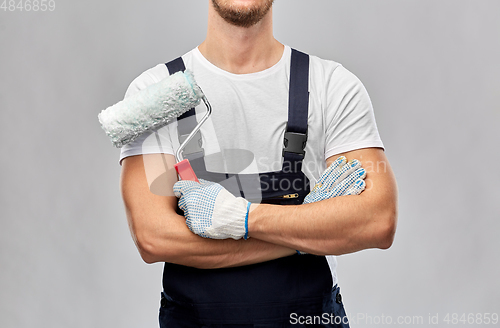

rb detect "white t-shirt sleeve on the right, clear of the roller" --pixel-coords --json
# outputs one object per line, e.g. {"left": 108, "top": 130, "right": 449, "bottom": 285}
{"left": 325, "top": 65, "right": 384, "bottom": 159}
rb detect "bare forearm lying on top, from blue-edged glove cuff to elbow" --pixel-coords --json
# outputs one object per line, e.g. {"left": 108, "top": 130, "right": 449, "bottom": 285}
{"left": 248, "top": 195, "right": 393, "bottom": 255}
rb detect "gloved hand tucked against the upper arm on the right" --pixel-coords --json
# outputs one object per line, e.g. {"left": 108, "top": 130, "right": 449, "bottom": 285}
{"left": 303, "top": 156, "right": 366, "bottom": 204}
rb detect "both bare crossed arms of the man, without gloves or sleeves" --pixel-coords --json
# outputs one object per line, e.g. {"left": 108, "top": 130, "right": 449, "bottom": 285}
{"left": 121, "top": 148, "right": 397, "bottom": 268}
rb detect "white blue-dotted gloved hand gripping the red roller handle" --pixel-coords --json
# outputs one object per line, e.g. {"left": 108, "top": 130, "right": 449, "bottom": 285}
{"left": 174, "top": 179, "right": 250, "bottom": 239}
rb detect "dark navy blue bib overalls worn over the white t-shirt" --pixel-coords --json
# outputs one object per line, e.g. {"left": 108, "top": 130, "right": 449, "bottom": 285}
{"left": 159, "top": 50, "right": 349, "bottom": 328}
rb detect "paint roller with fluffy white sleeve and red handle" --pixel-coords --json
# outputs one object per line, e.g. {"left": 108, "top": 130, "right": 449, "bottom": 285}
{"left": 98, "top": 70, "right": 212, "bottom": 182}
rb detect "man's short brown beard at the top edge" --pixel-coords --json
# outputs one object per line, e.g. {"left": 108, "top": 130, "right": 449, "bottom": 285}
{"left": 212, "top": 0, "right": 274, "bottom": 27}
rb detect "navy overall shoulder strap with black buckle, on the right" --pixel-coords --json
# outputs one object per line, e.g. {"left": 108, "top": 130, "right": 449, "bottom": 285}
{"left": 283, "top": 49, "right": 309, "bottom": 167}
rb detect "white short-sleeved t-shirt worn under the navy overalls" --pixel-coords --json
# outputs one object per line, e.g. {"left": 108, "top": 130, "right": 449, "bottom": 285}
{"left": 120, "top": 46, "right": 383, "bottom": 283}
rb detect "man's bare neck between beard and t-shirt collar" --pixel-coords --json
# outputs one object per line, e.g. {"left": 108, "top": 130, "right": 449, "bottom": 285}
{"left": 198, "top": 5, "right": 284, "bottom": 74}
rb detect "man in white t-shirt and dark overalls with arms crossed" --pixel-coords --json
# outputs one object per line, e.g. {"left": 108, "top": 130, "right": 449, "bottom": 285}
{"left": 121, "top": 0, "right": 397, "bottom": 327}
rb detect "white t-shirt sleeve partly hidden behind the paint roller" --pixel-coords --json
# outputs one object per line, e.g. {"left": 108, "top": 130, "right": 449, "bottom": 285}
{"left": 119, "top": 66, "right": 174, "bottom": 165}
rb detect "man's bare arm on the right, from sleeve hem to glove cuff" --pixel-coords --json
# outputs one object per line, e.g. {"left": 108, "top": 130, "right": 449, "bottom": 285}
{"left": 248, "top": 149, "right": 397, "bottom": 255}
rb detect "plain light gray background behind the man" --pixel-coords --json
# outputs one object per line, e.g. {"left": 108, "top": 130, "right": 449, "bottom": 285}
{"left": 0, "top": 0, "right": 500, "bottom": 328}
